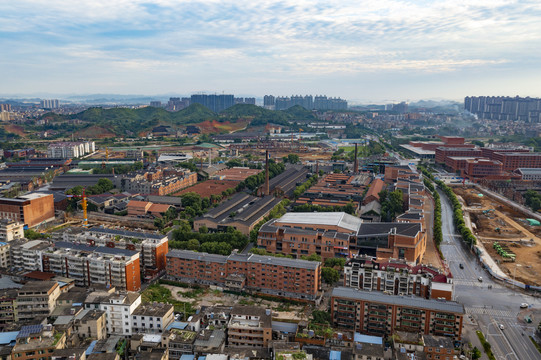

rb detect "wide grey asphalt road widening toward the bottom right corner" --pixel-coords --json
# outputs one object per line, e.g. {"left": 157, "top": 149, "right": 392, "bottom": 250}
{"left": 439, "top": 191, "right": 541, "bottom": 360}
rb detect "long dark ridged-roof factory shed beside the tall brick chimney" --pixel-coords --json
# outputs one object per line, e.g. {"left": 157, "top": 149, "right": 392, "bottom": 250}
{"left": 194, "top": 192, "right": 282, "bottom": 236}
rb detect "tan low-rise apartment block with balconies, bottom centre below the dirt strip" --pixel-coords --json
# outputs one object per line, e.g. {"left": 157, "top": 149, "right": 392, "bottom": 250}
{"left": 227, "top": 305, "right": 272, "bottom": 348}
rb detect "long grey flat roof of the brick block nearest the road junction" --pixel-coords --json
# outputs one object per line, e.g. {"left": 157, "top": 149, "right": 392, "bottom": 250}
{"left": 331, "top": 287, "right": 465, "bottom": 314}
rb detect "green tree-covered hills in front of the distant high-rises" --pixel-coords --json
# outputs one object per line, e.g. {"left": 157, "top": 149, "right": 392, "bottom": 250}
{"left": 42, "top": 104, "right": 317, "bottom": 135}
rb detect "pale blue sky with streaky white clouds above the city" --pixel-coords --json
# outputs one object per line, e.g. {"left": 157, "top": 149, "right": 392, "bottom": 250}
{"left": 0, "top": 0, "right": 541, "bottom": 103}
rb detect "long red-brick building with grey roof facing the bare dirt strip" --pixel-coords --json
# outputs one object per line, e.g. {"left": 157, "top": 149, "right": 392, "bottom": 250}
{"left": 167, "top": 250, "right": 321, "bottom": 301}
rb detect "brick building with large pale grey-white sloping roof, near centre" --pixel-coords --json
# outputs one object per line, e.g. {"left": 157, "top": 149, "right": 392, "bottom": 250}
{"left": 257, "top": 212, "right": 362, "bottom": 259}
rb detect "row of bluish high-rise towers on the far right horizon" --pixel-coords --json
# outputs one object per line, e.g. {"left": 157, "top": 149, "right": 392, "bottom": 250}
{"left": 464, "top": 96, "right": 541, "bottom": 123}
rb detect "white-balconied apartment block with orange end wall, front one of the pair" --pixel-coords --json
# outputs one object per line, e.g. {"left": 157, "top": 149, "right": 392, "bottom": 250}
{"left": 42, "top": 241, "right": 141, "bottom": 291}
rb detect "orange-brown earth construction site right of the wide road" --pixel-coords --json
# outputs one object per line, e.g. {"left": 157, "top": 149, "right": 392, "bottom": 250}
{"left": 453, "top": 186, "right": 541, "bottom": 286}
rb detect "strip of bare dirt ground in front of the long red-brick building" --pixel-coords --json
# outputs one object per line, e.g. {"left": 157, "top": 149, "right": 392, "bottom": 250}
{"left": 162, "top": 285, "right": 311, "bottom": 321}
